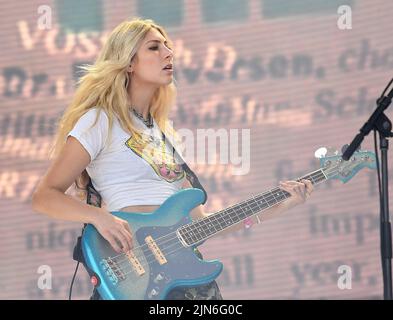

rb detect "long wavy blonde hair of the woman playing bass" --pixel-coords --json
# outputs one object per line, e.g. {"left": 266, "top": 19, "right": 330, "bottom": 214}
{"left": 50, "top": 18, "right": 177, "bottom": 199}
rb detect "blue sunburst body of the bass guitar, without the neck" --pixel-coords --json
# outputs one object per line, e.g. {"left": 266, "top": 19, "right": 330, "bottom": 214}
{"left": 82, "top": 188, "right": 223, "bottom": 300}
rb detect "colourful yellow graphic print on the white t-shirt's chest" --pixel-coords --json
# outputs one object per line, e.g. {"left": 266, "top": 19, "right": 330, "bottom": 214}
{"left": 126, "top": 133, "right": 185, "bottom": 182}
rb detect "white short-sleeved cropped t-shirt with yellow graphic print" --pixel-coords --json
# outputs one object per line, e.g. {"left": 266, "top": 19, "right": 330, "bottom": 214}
{"left": 68, "top": 108, "right": 186, "bottom": 211}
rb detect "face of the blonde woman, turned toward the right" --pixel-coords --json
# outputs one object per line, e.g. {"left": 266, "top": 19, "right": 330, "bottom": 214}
{"left": 129, "top": 28, "right": 173, "bottom": 86}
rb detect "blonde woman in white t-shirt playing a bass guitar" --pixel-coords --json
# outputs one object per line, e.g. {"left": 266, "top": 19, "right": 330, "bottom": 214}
{"left": 33, "top": 18, "right": 312, "bottom": 299}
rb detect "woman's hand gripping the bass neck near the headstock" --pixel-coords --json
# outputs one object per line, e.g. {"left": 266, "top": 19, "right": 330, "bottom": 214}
{"left": 279, "top": 179, "right": 314, "bottom": 209}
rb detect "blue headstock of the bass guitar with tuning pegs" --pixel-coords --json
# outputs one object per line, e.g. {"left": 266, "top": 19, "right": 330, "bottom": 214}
{"left": 315, "top": 145, "right": 376, "bottom": 183}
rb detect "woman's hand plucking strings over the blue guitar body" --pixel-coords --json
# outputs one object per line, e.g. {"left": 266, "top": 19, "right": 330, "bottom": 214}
{"left": 93, "top": 211, "right": 133, "bottom": 253}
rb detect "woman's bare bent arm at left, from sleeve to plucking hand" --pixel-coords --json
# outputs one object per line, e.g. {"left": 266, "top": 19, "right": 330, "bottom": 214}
{"left": 32, "top": 136, "right": 132, "bottom": 252}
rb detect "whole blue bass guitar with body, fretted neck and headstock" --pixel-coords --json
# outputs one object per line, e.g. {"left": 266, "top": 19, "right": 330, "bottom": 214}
{"left": 82, "top": 151, "right": 375, "bottom": 300}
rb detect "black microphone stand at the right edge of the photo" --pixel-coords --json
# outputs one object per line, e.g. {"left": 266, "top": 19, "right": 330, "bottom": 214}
{"left": 342, "top": 89, "right": 393, "bottom": 300}
